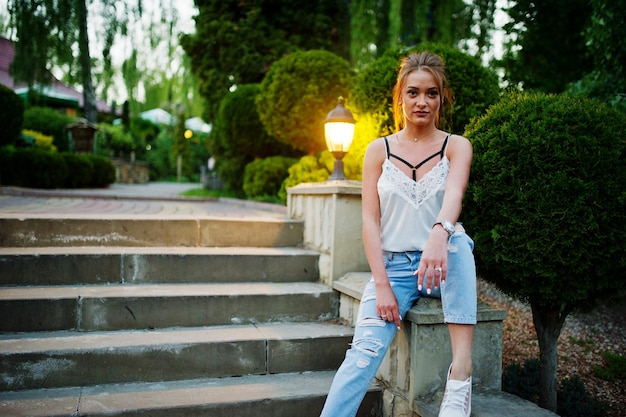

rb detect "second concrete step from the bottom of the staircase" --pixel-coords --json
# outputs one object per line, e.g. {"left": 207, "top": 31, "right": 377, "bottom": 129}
{"left": 0, "top": 322, "right": 352, "bottom": 390}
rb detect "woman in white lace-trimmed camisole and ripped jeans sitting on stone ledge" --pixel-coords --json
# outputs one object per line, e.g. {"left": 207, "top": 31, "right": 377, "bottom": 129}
{"left": 322, "top": 52, "right": 476, "bottom": 417}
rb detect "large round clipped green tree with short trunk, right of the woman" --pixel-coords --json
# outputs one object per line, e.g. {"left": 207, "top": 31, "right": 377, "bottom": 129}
{"left": 462, "top": 93, "right": 626, "bottom": 411}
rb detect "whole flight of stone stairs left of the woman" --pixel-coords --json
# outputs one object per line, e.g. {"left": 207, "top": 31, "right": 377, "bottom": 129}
{"left": 0, "top": 216, "right": 380, "bottom": 417}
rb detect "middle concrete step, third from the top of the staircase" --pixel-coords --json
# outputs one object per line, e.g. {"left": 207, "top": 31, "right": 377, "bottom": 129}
{"left": 0, "top": 282, "right": 338, "bottom": 332}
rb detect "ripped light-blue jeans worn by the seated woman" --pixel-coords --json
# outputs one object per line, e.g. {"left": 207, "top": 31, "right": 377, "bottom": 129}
{"left": 321, "top": 231, "right": 477, "bottom": 417}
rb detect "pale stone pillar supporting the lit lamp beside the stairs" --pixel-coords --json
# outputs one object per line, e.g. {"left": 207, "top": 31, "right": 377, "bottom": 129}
{"left": 287, "top": 181, "right": 369, "bottom": 287}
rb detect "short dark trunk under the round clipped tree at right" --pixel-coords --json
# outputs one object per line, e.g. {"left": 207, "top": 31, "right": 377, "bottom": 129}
{"left": 530, "top": 301, "right": 567, "bottom": 412}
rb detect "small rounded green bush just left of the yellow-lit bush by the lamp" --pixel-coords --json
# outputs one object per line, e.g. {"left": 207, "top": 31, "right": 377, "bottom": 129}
{"left": 243, "top": 156, "right": 298, "bottom": 202}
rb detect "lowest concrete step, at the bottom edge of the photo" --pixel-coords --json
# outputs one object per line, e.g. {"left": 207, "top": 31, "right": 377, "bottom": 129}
{"left": 0, "top": 371, "right": 381, "bottom": 417}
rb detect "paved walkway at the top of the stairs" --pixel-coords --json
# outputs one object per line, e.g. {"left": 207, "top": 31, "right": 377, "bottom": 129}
{"left": 0, "top": 182, "right": 287, "bottom": 218}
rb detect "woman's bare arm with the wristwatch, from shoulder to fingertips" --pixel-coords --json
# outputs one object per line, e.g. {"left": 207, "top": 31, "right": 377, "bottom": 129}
{"left": 417, "top": 136, "right": 473, "bottom": 291}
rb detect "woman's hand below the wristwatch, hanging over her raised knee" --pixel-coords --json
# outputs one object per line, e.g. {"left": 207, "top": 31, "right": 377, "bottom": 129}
{"left": 415, "top": 227, "right": 448, "bottom": 294}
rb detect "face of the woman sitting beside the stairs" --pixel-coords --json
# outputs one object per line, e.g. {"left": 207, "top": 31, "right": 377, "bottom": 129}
{"left": 402, "top": 70, "right": 441, "bottom": 127}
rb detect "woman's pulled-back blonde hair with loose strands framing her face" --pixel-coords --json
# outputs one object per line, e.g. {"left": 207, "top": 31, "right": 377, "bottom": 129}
{"left": 392, "top": 52, "right": 452, "bottom": 130}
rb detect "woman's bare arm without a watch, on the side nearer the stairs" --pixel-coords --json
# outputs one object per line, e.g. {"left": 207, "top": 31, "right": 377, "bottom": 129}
{"left": 361, "top": 139, "right": 400, "bottom": 327}
